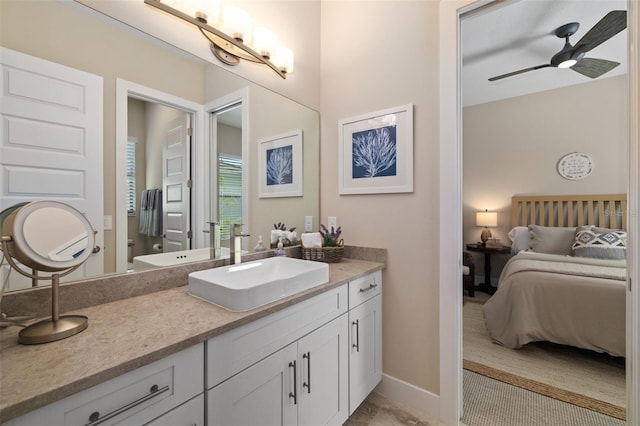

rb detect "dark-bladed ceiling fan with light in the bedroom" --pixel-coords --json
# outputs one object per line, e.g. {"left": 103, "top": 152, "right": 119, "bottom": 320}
{"left": 489, "top": 10, "right": 627, "bottom": 81}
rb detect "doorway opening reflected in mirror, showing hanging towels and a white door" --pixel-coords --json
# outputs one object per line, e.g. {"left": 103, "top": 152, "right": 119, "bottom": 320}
{"left": 127, "top": 97, "right": 192, "bottom": 269}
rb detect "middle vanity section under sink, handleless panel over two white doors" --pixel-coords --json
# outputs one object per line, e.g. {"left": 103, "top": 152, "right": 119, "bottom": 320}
{"left": 207, "top": 285, "right": 349, "bottom": 426}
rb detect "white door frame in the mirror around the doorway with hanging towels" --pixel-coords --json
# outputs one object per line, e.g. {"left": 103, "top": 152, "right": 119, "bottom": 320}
{"left": 115, "top": 78, "right": 204, "bottom": 273}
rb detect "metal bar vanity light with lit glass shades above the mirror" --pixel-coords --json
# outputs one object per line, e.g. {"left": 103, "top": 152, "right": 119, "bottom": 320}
{"left": 144, "top": 0, "right": 293, "bottom": 78}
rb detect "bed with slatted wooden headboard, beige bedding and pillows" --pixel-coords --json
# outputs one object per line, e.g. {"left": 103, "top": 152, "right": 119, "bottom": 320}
{"left": 483, "top": 194, "right": 627, "bottom": 356}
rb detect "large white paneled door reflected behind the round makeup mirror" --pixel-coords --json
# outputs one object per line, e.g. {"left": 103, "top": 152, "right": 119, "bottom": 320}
{"left": 0, "top": 48, "right": 104, "bottom": 286}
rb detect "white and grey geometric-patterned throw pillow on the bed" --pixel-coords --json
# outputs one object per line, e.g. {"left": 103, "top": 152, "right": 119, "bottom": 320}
{"left": 572, "top": 230, "right": 627, "bottom": 259}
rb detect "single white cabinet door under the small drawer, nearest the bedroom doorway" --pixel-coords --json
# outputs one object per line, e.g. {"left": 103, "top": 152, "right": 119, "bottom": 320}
{"left": 349, "top": 295, "right": 382, "bottom": 415}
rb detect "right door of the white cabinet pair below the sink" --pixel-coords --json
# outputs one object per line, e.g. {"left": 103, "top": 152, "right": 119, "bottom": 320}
{"left": 298, "top": 314, "right": 349, "bottom": 426}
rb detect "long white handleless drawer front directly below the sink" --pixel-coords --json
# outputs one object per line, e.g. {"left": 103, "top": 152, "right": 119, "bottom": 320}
{"left": 207, "top": 284, "right": 347, "bottom": 389}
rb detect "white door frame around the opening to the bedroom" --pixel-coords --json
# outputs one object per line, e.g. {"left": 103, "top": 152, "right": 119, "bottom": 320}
{"left": 439, "top": 0, "right": 640, "bottom": 425}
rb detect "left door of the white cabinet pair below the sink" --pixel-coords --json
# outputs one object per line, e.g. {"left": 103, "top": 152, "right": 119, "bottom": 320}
{"left": 207, "top": 343, "right": 300, "bottom": 426}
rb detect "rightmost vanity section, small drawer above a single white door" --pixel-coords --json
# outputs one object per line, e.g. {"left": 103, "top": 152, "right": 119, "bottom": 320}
{"left": 349, "top": 271, "right": 382, "bottom": 415}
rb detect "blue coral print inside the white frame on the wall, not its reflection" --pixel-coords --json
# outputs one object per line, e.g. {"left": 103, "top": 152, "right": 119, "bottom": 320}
{"left": 351, "top": 125, "right": 396, "bottom": 179}
